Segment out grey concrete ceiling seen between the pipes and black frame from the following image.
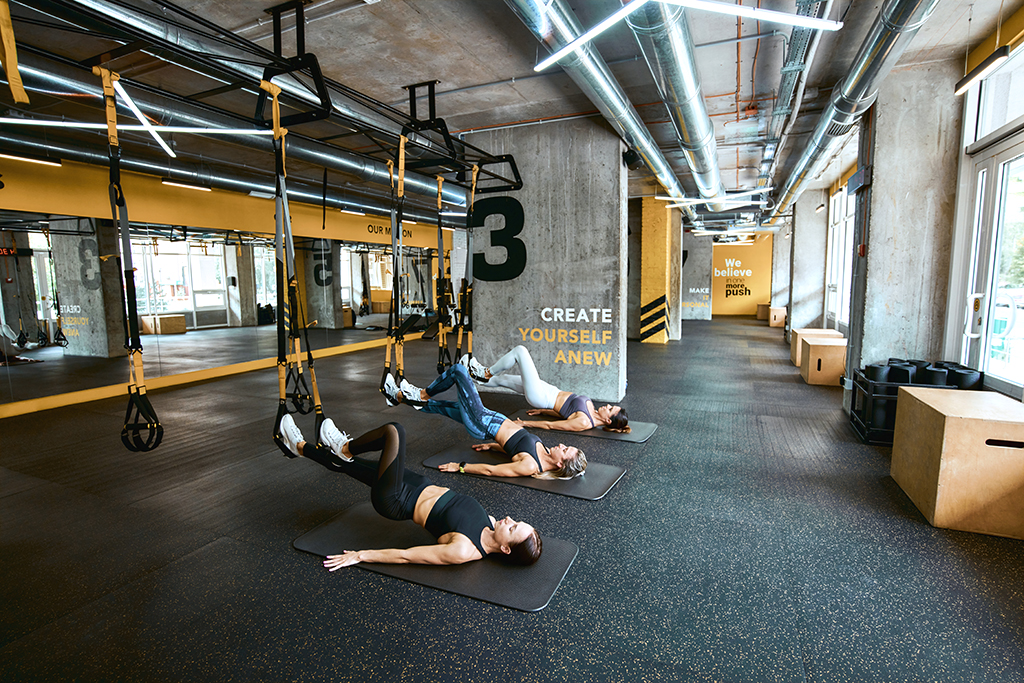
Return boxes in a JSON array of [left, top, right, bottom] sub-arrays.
[[0, 0, 1007, 229]]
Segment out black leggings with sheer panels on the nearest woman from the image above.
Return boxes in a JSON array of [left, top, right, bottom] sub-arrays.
[[302, 422, 431, 520]]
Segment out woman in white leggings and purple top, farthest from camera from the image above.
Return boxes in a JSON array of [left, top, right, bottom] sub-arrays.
[[459, 345, 630, 433]]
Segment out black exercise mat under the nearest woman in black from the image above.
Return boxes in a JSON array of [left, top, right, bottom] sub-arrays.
[[292, 502, 580, 612]]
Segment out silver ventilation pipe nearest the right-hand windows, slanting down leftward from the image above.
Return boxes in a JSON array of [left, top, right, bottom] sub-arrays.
[[768, 0, 938, 224]]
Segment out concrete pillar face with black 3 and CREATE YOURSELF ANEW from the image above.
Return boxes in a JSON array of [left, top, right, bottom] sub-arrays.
[[467, 119, 627, 400]]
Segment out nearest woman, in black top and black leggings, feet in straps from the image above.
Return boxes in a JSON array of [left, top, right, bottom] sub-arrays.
[[281, 415, 541, 571]]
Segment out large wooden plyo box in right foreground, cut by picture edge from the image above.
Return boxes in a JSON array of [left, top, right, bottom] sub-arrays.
[[890, 387, 1024, 540]]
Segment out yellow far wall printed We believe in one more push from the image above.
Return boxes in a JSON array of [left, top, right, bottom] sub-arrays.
[[711, 232, 772, 315]]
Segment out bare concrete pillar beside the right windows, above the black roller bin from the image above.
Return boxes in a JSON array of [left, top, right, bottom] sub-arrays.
[[850, 60, 963, 368]]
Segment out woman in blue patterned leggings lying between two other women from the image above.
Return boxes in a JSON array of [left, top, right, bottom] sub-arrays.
[[384, 366, 587, 479]]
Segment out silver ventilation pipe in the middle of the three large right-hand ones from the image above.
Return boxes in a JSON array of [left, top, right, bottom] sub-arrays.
[[626, 2, 726, 212]]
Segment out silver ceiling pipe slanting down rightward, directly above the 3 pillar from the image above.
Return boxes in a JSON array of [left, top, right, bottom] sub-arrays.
[[505, 0, 696, 220]]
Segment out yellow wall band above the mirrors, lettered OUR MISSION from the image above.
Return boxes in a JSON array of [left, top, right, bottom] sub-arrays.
[[0, 159, 451, 249]]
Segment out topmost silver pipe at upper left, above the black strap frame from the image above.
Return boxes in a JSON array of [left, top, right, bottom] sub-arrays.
[[51, 0, 464, 181]]
